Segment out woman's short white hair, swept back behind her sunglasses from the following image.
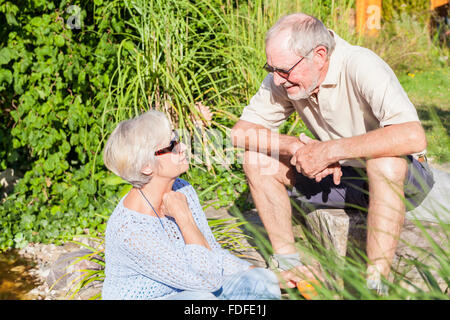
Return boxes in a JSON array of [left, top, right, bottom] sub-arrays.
[[103, 110, 171, 188]]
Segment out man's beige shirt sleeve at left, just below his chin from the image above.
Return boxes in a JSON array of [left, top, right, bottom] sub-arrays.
[[240, 74, 295, 131]]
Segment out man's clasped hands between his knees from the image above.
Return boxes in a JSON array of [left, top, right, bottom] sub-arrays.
[[291, 133, 342, 185]]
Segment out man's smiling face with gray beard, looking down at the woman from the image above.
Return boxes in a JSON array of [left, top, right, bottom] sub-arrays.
[[266, 32, 320, 100]]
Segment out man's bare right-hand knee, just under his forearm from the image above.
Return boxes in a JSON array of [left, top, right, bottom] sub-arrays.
[[366, 157, 408, 185]]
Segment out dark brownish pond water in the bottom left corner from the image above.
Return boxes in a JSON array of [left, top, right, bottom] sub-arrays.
[[0, 250, 39, 300]]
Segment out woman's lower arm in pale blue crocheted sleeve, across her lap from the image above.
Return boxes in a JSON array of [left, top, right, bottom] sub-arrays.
[[117, 221, 224, 291]]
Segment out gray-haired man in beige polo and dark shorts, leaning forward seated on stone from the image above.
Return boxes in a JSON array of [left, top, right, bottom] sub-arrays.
[[231, 13, 434, 293]]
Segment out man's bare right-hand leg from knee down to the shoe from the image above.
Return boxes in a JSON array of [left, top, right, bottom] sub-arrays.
[[367, 157, 408, 278]]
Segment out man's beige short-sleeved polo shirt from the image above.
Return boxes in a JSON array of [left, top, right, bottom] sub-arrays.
[[240, 31, 419, 167]]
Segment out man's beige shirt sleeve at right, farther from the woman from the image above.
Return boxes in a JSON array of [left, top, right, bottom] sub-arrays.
[[347, 48, 419, 127]]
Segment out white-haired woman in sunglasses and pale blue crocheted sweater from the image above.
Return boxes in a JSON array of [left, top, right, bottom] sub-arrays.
[[102, 111, 280, 300]]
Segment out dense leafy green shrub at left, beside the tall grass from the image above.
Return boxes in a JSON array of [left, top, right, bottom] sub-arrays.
[[0, 1, 126, 249]]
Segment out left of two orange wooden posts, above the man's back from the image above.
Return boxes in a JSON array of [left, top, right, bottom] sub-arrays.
[[356, 0, 382, 36]]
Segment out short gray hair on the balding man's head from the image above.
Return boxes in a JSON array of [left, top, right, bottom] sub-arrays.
[[266, 13, 336, 57]]
